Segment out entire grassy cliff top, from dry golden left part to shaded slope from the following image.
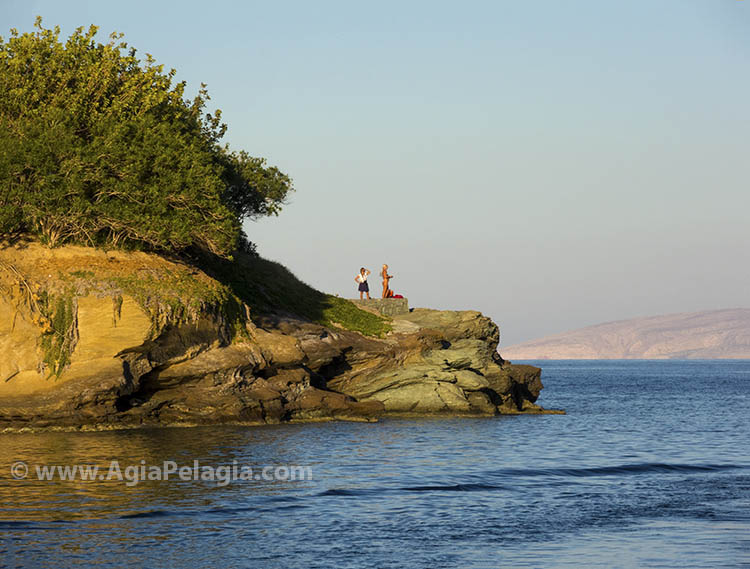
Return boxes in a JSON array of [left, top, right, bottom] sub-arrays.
[[4, 242, 391, 338]]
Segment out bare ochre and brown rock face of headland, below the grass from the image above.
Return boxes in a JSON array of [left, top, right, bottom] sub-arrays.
[[0, 244, 556, 429]]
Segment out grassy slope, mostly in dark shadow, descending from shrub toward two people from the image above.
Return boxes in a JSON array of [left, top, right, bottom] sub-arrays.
[[202, 254, 391, 337]]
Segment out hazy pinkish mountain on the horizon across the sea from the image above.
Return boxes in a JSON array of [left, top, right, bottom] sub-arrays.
[[500, 308, 750, 360]]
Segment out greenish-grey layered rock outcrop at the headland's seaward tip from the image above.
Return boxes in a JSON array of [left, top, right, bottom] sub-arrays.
[[327, 309, 542, 415]]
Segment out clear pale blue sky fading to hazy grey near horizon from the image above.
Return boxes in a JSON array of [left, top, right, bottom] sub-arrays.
[[0, 0, 750, 344]]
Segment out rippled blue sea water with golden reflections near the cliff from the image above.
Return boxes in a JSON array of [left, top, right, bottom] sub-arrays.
[[0, 361, 750, 568]]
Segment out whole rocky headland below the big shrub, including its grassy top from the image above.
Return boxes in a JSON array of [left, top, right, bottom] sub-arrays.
[[0, 242, 560, 430]]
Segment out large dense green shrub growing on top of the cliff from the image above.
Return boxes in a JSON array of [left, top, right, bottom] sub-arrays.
[[0, 18, 292, 255]]
